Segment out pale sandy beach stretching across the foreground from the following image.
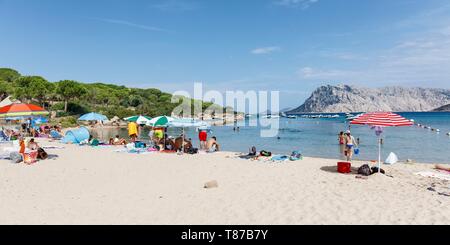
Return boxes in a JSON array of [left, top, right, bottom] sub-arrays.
[[0, 140, 450, 225]]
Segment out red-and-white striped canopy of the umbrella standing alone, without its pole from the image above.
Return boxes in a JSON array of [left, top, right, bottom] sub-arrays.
[[351, 112, 414, 127]]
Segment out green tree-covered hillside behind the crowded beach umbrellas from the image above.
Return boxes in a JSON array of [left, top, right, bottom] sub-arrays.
[[0, 68, 225, 118]]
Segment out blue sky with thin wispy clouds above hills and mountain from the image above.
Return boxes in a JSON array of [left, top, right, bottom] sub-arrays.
[[0, 0, 450, 107]]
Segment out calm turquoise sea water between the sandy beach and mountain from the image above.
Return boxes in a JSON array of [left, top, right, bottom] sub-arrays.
[[96, 112, 450, 163]]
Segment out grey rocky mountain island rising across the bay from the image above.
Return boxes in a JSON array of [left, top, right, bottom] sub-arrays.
[[288, 85, 450, 114]]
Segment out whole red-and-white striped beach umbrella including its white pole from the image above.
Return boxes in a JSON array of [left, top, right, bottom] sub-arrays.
[[350, 112, 414, 172]]
